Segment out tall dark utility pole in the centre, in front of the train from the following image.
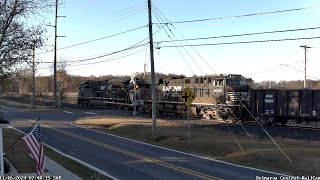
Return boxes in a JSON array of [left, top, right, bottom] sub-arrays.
[[148, 0, 157, 136]]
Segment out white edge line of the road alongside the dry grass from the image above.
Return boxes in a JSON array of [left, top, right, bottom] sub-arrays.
[[69, 123, 289, 177]]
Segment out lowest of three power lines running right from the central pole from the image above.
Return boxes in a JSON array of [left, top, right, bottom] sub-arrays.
[[161, 36, 320, 48]]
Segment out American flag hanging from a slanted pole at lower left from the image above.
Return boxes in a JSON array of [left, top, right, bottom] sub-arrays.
[[22, 124, 45, 176]]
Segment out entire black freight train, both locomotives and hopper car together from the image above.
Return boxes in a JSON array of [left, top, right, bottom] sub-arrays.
[[78, 74, 320, 126]]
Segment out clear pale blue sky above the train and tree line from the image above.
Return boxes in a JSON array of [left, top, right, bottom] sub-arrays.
[[32, 0, 320, 81]]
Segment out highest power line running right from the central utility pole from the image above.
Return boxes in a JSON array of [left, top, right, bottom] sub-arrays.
[[156, 5, 320, 24]]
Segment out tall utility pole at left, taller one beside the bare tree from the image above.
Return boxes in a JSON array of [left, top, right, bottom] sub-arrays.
[[53, 0, 58, 106]]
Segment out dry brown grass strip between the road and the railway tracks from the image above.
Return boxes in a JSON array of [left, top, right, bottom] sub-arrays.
[[76, 116, 320, 176]]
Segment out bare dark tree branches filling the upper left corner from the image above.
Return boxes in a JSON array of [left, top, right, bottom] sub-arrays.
[[0, 0, 50, 77]]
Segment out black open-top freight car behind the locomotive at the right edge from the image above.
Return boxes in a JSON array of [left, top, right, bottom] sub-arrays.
[[250, 89, 320, 125]]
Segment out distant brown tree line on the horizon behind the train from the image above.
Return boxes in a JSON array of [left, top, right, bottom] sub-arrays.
[[0, 66, 320, 96]]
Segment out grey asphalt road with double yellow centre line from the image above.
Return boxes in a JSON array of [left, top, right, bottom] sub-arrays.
[[2, 109, 288, 180]]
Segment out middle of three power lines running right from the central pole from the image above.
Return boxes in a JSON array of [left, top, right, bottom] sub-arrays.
[[156, 26, 320, 43]]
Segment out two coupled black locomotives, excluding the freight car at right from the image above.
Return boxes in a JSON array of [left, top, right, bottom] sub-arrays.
[[78, 74, 251, 119]]
